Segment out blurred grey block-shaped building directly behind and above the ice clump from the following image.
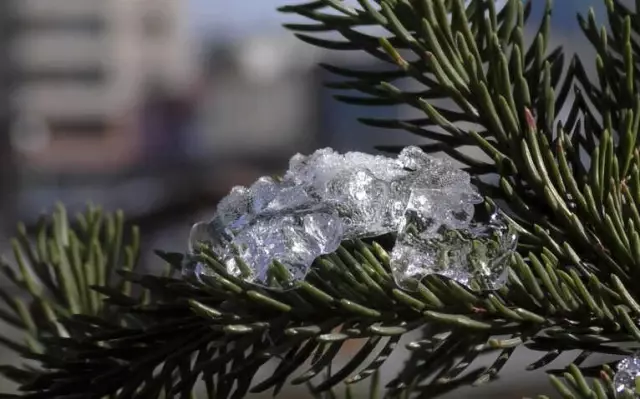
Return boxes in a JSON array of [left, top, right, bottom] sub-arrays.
[[192, 35, 316, 164]]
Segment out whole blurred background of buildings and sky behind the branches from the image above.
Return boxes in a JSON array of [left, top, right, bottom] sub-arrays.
[[0, 0, 620, 398]]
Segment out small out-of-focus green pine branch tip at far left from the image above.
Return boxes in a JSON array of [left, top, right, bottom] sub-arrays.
[[0, 206, 146, 383]]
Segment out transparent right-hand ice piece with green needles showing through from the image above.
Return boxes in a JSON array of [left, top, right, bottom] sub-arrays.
[[391, 199, 517, 290]]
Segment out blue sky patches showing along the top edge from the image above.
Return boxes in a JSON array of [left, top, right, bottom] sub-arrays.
[[194, 0, 604, 36]]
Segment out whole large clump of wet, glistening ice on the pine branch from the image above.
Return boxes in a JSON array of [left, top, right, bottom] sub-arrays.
[[190, 147, 515, 288]]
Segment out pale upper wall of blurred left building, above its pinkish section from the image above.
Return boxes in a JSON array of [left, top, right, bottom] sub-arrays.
[[11, 0, 194, 125]]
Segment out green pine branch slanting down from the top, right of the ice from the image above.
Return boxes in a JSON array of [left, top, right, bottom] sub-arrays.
[[282, 0, 599, 266]]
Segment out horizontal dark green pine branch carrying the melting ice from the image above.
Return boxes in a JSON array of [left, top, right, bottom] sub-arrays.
[[5, 219, 640, 398]]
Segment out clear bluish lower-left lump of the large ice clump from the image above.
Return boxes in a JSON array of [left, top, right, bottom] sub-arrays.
[[190, 194, 344, 286]]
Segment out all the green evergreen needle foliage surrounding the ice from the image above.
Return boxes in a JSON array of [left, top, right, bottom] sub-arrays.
[[0, 0, 640, 399]]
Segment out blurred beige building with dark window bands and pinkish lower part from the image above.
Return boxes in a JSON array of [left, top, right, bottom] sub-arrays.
[[8, 0, 195, 173]]
